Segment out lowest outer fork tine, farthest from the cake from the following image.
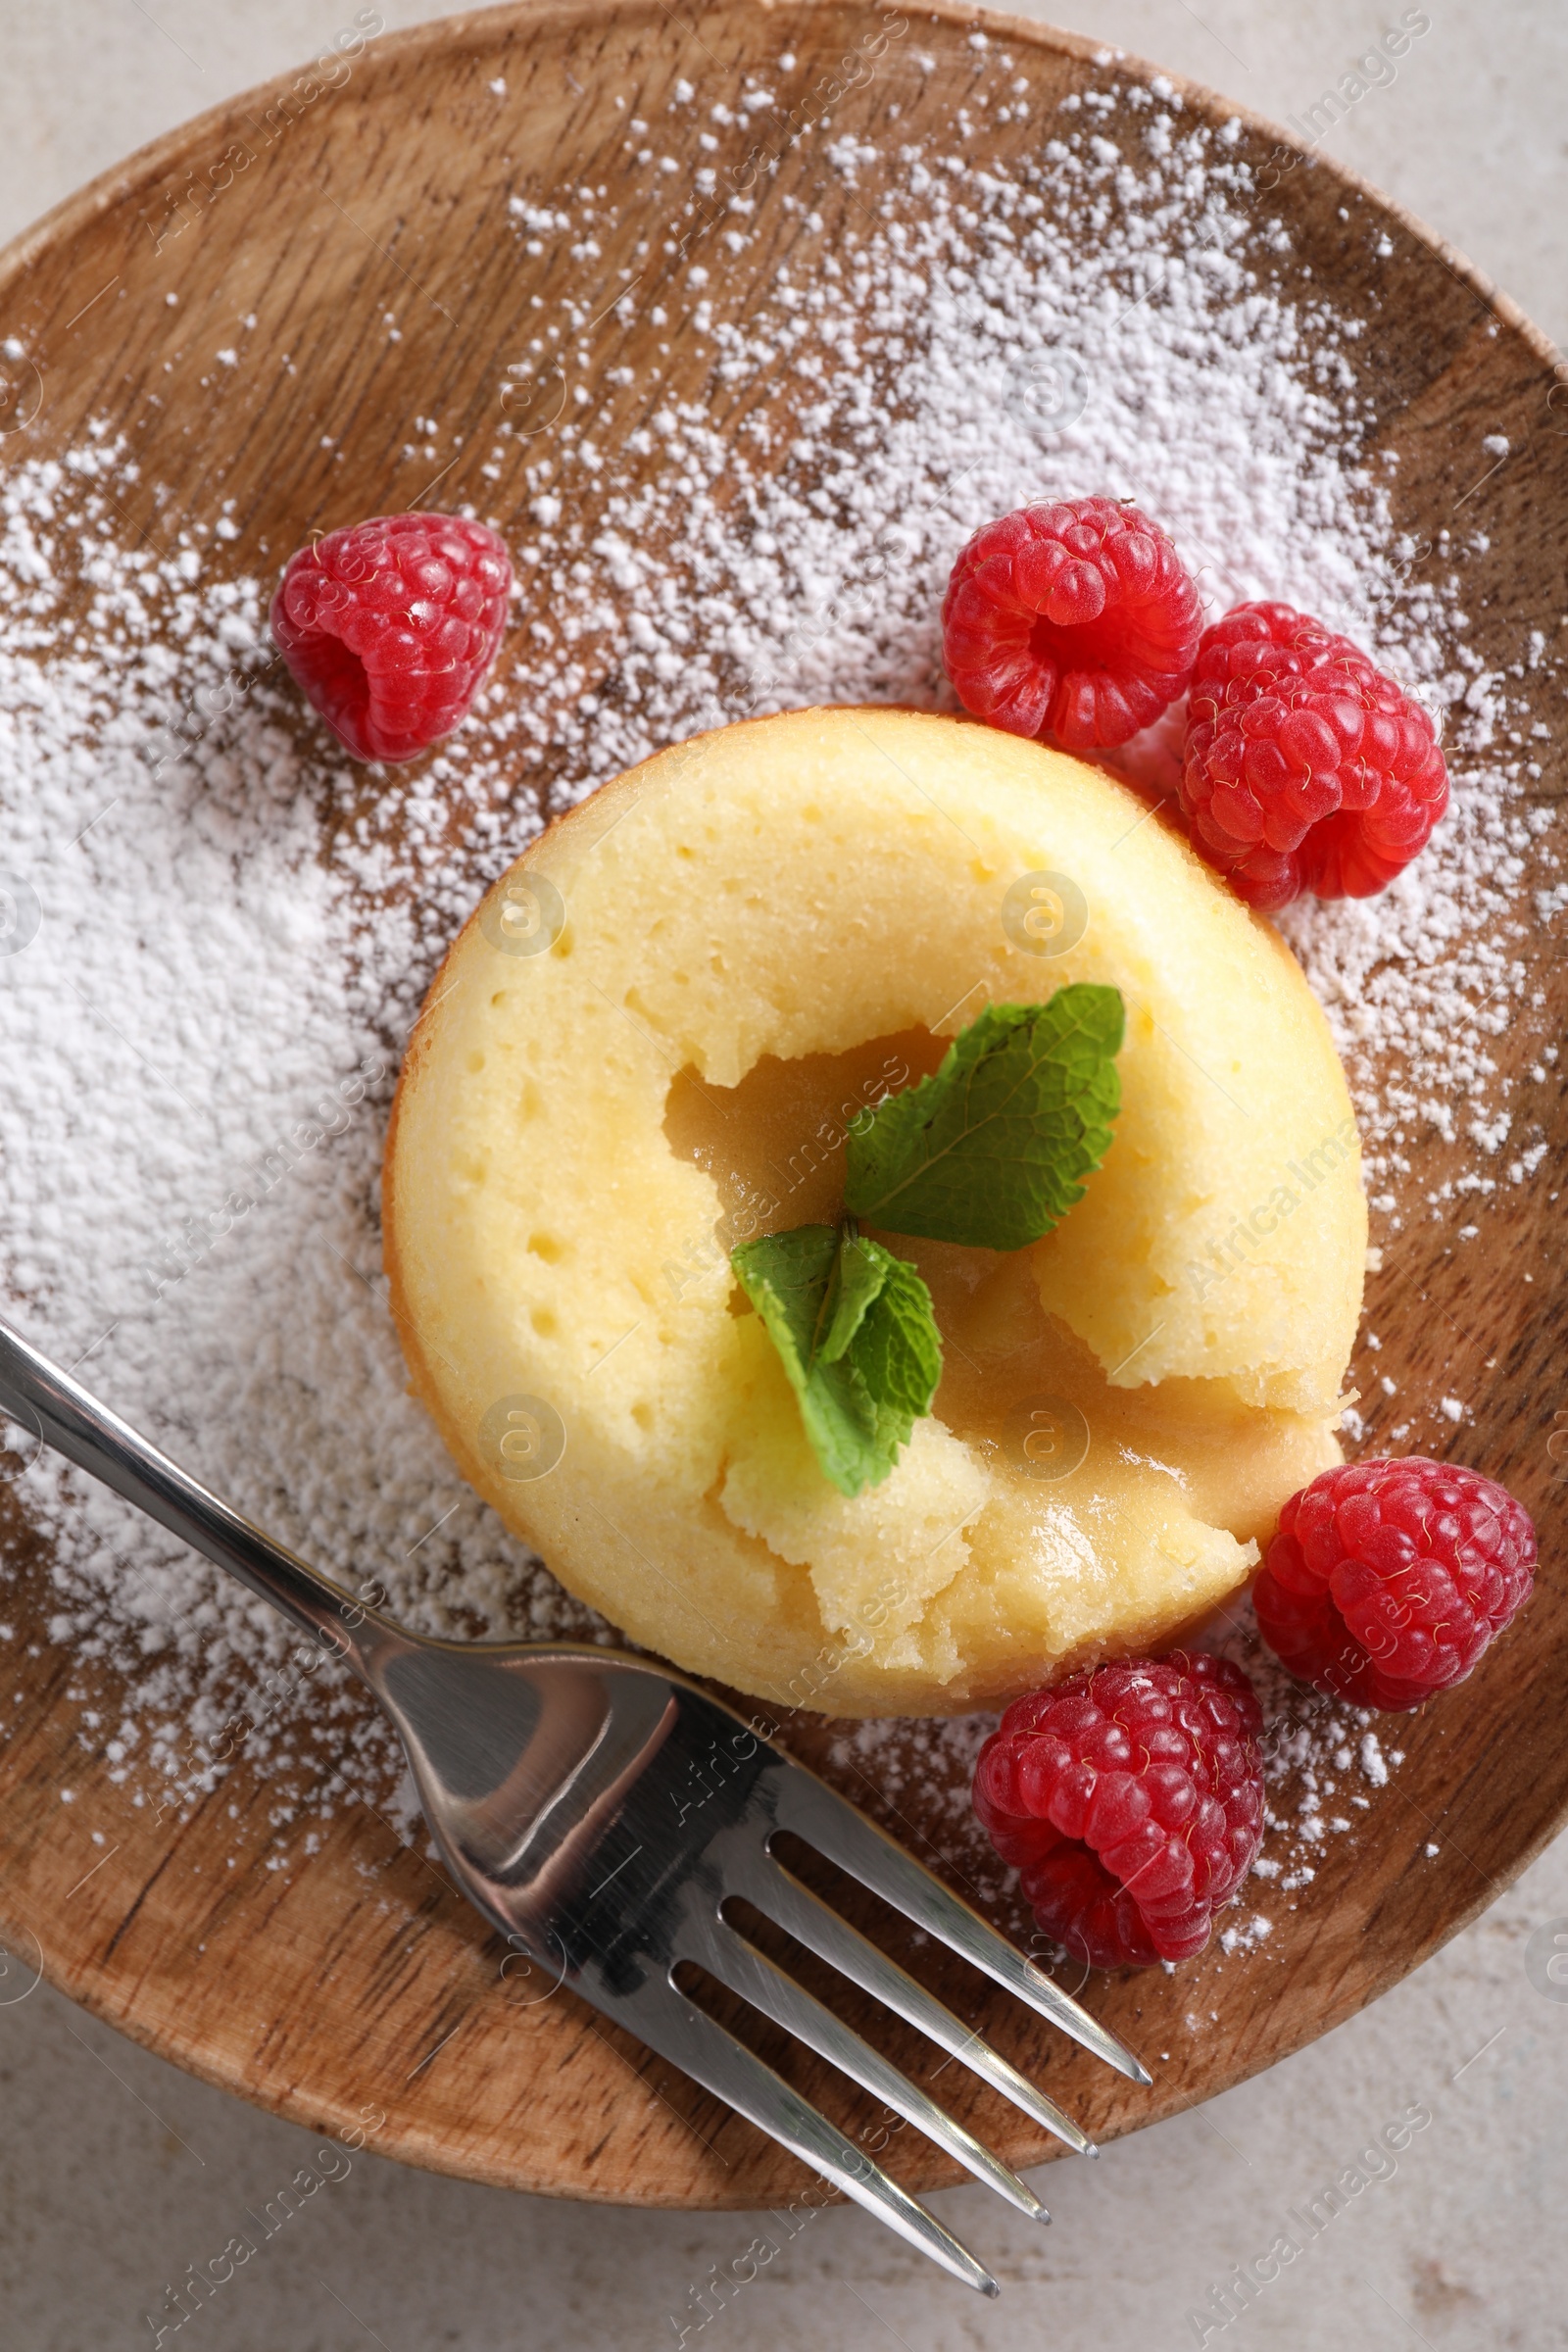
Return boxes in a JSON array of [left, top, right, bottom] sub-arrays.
[[600, 1981, 999, 2295]]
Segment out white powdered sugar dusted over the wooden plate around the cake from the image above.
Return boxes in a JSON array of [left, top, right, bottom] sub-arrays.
[[0, 57, 1549, 1882]]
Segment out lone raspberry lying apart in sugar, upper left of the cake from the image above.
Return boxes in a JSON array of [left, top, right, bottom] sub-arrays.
[[272, 515, 513, 760]]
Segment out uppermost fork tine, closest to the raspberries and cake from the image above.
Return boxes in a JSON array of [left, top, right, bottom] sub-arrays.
[[773, 1762, 1154, 2082]]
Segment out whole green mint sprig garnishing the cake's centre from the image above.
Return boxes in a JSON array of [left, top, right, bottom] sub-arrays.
[[731, 981, 1126, 1495]]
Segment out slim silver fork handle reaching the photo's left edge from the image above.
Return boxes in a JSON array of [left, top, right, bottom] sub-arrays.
[[0, 1322, 393, 1675]]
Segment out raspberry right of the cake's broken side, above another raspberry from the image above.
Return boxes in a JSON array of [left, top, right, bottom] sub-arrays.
[[1253, 1453, 1535, 1712]]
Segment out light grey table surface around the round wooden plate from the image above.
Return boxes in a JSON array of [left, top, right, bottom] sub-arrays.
[[0, 0, 1568, 2352]]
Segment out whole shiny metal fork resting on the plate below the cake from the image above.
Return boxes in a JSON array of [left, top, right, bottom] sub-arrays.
[[0, 1322, 1150, 2295]]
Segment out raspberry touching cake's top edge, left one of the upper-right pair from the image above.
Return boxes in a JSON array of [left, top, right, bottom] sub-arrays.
[[943, 499, 1201, 751]]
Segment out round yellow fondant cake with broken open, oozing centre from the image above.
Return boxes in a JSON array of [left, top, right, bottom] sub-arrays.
[[385, 710, 1366, 1715]]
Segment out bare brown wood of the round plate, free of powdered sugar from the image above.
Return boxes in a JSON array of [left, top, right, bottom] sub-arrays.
[[0, 0, 1568, 2206]]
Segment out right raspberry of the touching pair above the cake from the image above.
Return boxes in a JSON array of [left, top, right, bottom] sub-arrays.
[[1180, 605, 1448, 907]]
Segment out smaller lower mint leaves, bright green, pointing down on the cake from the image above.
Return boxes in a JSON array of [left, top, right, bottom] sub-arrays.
[[729, 1225, 943, 1494]]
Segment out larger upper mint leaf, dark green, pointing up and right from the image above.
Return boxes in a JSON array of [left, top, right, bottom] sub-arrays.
[[844, 981, 1124, 1249]]
